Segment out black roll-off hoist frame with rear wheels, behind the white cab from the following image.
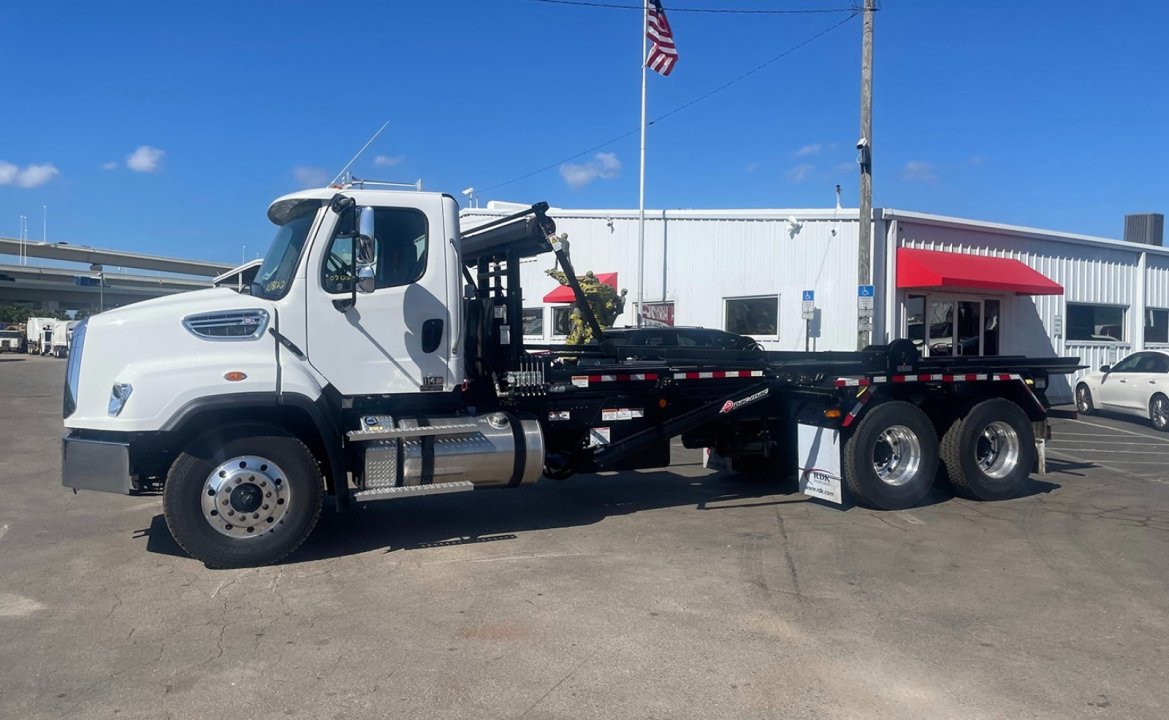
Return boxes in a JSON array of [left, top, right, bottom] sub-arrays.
[[451, 203, 1080, 510]]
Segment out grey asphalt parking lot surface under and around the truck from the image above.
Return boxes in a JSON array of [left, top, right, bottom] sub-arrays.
[[0, 358, 1169, 719]]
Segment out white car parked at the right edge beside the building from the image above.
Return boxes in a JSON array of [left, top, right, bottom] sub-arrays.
[[1075, 349, 1169, 431]]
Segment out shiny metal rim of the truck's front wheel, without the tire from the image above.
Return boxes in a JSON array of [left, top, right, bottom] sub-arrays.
[[202, 455, 292, 538]]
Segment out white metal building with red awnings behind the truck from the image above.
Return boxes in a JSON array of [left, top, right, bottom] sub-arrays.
[[463, 203, 1169, 401]]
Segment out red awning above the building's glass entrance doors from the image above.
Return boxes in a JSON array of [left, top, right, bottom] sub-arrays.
[[897, 248, 1064, 295]]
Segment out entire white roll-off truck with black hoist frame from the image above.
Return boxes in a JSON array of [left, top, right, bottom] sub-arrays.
[[62, 182, 1079, 567]]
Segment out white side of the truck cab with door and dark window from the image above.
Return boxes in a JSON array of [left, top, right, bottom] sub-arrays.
[[305, 192, 457, 395]]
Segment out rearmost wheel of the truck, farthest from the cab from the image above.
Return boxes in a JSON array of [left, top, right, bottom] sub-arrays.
[[941, 397, 1036, 500]]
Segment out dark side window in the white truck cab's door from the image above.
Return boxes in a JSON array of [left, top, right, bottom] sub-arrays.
[[320, 208, 429, 292]]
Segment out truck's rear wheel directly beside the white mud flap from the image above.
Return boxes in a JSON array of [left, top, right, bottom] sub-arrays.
[[844, 401, 938, 510]]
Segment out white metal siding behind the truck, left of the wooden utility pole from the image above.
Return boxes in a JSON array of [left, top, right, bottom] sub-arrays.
[[463, 210, 858, 349]]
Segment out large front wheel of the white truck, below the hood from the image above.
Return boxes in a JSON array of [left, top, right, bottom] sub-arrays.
[[162, 424, 324, 568]]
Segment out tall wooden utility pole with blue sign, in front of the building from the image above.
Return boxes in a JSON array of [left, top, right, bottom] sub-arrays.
[[857, 0, 874, 349]]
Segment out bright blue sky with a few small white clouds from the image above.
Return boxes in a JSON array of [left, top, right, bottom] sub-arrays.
[[0, 0, 1169, 262]]
